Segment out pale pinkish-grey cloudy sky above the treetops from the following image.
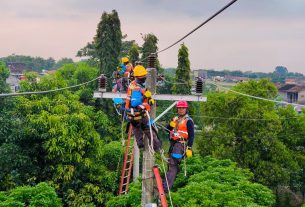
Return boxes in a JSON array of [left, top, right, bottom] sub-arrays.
[[0, 0, 305, 74]]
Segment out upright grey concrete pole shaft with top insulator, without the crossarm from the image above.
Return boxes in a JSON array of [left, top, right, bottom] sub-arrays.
[[141, 54, 157, 206]]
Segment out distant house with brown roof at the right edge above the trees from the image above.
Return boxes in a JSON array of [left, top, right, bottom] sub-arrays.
[[278, 84, 305, 104]]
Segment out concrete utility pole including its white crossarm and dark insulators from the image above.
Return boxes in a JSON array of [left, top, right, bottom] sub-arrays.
[[94, 59, 207, 207]]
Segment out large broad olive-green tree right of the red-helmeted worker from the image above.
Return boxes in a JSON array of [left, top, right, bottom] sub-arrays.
[[197, 80, 305, 205]]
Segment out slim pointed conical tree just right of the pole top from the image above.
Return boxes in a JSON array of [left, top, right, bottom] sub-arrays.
[[173, 44, 192, 94]]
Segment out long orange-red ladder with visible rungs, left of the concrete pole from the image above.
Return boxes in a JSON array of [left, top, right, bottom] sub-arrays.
[[119, 124, 134, 195]]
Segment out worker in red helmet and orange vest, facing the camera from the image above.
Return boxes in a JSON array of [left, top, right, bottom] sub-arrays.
[[163, 101, 195, 192]]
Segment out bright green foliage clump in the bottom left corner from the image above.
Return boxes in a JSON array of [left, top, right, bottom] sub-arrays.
[[0, 183, 62, 207]]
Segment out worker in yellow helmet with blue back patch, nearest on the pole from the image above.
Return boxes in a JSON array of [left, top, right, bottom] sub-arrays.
[[125, 65, 161, 151]]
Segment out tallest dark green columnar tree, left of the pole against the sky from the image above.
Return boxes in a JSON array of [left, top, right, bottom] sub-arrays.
[[94, 10, 122, 79]]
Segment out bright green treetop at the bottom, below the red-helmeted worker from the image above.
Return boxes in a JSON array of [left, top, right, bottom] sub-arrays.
[[172, 157, 275, 207]]
